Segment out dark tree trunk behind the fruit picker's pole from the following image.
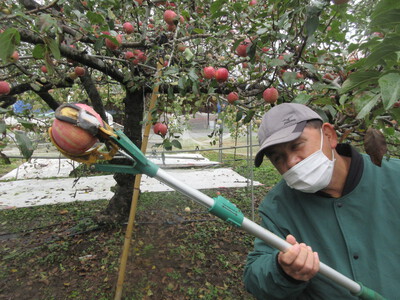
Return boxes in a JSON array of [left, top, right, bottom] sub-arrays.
[[101, 91, 144, 222]]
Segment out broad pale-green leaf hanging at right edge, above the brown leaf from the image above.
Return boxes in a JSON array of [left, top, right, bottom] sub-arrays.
[[378, 73, 400, 110]]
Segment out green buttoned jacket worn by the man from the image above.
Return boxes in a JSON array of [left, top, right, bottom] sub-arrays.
[[244, 155, 400, 300]]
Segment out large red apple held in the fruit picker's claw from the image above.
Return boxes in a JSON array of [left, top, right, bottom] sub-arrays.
[[51, 103, 103, 154]]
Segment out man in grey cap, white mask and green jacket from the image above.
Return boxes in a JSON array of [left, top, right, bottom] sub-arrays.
[[244, 103, 400, 300]]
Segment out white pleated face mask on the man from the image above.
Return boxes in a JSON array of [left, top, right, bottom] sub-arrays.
[[282, 129, 335, 193]]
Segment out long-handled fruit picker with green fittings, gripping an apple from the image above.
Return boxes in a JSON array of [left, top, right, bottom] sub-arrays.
[[49, 104, 385, 300]]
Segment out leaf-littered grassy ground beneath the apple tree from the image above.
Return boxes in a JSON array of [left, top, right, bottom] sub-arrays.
[[0, 113, 279, 299]]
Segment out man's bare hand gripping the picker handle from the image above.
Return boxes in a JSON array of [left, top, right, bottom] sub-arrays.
[[278, 234, 319, 281]]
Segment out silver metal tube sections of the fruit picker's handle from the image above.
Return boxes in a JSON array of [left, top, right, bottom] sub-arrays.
[[154, 169, 361, 294]]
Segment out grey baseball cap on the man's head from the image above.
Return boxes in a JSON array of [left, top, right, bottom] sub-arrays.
[[254, 103, 322, 167]]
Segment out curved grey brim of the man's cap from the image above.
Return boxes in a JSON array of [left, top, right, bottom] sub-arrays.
[[254, 121, 307, 167]]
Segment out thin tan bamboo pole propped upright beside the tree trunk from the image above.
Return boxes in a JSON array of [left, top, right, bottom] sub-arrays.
[[114, 60, 163, 300]]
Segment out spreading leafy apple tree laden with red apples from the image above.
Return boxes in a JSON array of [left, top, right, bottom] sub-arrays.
[[0, 0, 400, 218]]
